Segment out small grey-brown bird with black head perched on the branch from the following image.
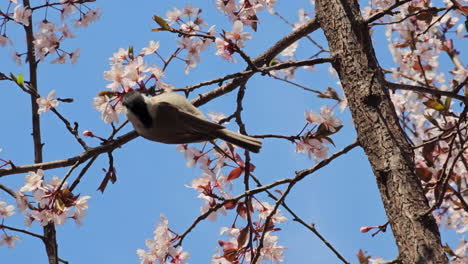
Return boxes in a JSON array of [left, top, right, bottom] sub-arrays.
[[122, 90, 262, 153]]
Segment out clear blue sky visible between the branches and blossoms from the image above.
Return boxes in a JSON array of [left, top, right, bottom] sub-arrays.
[[0, 0, 457, 264]]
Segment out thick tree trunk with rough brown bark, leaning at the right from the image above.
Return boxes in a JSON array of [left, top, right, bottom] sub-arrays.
[[316, 0, 448, 264]]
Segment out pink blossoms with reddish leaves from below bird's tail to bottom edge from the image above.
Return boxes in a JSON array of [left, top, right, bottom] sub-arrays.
[[177, 139, 286, 264]]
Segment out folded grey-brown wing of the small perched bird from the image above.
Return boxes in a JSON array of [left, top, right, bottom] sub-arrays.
[[155, 102, 224, 135]]
